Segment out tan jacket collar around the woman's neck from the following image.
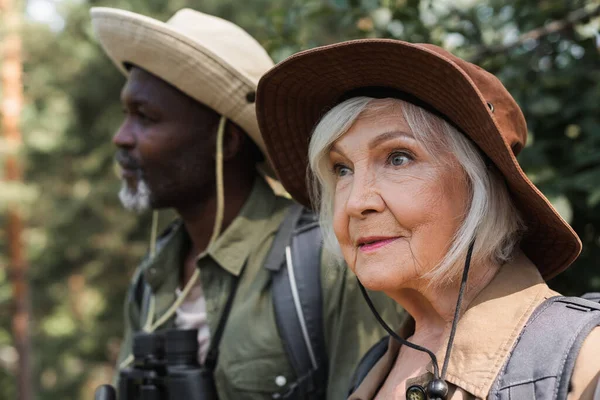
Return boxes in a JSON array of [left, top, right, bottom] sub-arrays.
[[351, 253, 557, 399]]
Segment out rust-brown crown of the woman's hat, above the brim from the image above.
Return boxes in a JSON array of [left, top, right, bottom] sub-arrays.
[[420, 44, 527, 156]]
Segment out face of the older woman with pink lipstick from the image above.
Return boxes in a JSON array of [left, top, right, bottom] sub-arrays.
[[329, 100, 468, 293]]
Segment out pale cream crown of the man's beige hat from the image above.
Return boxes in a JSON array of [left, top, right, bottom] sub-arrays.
[[166, 8, 273, 85]]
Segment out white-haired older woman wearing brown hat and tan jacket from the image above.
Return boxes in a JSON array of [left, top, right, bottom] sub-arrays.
[[257, 39, 600, 400]]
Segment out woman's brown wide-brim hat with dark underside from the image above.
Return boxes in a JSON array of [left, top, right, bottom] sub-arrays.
[[256, 39, 581, 279]]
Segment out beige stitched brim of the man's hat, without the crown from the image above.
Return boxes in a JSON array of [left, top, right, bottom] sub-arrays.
[[91, 7, 266, 162]]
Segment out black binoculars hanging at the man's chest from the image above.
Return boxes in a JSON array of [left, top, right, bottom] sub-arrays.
[[95, 329, 218, 400]]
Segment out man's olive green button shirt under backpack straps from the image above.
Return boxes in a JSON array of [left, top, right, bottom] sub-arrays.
[[119, 178, 402, 400]]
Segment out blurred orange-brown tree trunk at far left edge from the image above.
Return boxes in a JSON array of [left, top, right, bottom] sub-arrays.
[[0, 0, 32, 400]]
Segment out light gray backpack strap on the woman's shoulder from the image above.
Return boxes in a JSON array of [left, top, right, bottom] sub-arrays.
[[488, 296, 600, 400]]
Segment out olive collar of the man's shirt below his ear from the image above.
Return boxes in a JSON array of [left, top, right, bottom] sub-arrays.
[[197, 177, 280, 276]]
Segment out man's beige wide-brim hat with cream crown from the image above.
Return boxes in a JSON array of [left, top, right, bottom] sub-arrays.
[[91, 7, 273, 155]]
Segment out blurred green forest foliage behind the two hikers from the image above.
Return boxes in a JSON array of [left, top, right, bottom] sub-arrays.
[[0, 0, 600, 399]]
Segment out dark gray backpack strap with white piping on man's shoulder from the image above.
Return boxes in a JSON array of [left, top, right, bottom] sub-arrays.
[[265, 205, 327, 400]]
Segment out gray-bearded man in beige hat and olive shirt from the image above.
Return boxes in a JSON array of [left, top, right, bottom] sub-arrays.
[[91, 8, 399, 399]]
